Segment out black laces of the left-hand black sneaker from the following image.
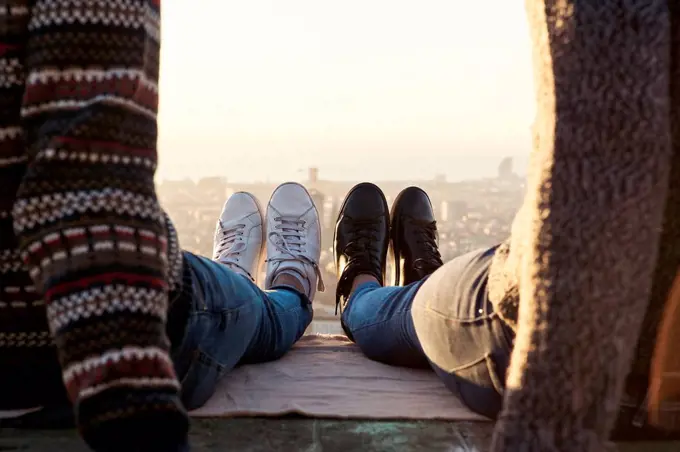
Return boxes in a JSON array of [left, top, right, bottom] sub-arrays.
[[335, 218, 380, 315]]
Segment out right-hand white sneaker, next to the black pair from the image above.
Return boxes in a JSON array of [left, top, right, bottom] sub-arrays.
[[265, 182, 325, 301]]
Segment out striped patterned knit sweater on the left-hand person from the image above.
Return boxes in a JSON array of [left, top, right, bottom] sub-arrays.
[[0, 0, 188, 451]]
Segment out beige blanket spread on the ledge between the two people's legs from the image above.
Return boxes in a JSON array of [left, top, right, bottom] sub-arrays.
[[0, 335, 485, 420]]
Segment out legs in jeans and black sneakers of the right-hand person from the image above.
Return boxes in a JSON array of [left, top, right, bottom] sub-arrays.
[[335, 184, 514, 418]]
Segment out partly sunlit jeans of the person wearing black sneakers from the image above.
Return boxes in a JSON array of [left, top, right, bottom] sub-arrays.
[[342, 247, 514, 418]]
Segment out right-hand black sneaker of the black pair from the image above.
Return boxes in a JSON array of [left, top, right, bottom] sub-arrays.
[[390, 187, 443, 286]]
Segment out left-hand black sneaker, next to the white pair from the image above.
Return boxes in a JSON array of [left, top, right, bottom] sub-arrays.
[[333, 183, 390, 339]]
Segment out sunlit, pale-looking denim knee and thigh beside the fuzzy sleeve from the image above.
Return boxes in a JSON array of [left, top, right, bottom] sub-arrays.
[[412, 248, 514, 418]]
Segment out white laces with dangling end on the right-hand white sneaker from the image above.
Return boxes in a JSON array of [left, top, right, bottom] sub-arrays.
[[266, 216, 326, 292]]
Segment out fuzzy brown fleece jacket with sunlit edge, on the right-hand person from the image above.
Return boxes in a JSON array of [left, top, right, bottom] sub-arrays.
[[489, 0, 680, 452]]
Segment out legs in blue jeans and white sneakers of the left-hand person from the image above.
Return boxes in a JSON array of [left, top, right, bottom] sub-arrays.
[[167, 183, 323, 410]]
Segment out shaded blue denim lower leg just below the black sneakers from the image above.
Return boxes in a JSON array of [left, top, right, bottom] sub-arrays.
[[342, 281, 428, 367]]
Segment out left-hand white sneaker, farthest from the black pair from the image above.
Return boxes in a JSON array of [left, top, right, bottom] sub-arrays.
[[213, 192, 264, 282]]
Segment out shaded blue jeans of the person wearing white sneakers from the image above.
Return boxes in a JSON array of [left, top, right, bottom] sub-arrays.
[[170, 252, 313, 410]]
